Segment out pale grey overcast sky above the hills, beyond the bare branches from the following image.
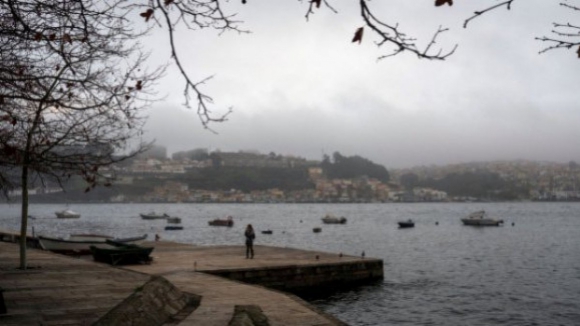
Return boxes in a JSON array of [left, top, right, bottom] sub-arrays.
[[146, 0, 580, 169]]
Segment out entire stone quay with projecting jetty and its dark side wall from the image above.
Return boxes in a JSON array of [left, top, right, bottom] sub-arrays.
[[0, 233, 383, 326]]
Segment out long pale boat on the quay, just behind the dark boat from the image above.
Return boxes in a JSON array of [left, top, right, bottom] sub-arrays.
[[38, 234, 147, 255]]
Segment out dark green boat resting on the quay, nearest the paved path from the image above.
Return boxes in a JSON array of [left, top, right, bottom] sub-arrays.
[[90, 240, 154, 266]]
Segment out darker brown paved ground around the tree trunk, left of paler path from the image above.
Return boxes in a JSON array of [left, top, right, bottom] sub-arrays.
[[0, 242, 150, 326]]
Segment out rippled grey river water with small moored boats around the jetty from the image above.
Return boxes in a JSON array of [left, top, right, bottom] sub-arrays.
[[0, 203, 580, 326]]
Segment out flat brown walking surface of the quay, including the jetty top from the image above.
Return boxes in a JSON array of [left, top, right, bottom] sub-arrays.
[[0, 242, 348, 326]]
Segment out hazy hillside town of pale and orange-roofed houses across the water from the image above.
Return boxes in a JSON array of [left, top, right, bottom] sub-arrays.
[[11, 146, 580, 203]]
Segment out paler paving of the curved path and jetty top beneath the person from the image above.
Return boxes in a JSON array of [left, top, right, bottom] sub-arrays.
[[124, 242, 360, 326]]
